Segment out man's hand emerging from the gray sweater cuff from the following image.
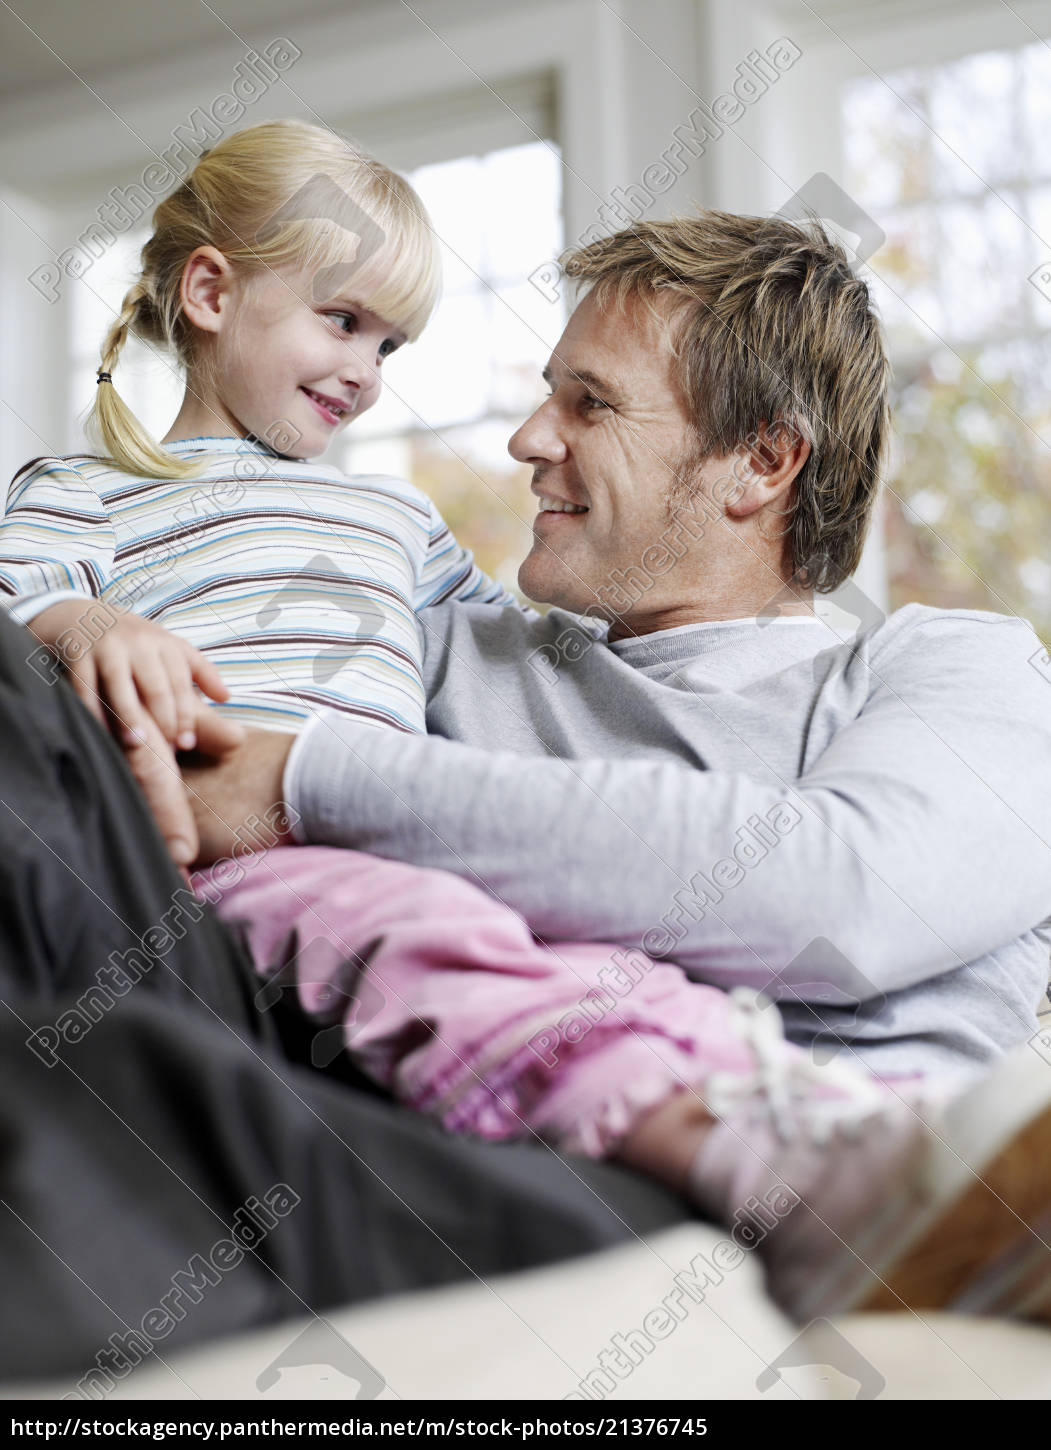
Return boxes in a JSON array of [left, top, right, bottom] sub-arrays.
[[180, 729, 296, 866]]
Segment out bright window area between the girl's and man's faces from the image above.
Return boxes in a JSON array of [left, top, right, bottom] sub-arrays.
[[341, 142, 564, 587]]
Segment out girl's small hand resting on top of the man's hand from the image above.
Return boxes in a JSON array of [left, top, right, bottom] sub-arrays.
[[29, 599, 229, 750]]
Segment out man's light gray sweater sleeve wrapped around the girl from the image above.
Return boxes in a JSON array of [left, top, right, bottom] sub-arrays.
[[286, 616, 1051, 1001]]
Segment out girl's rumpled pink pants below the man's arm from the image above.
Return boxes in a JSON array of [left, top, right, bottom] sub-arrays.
[[194, 845, 752, 1157]]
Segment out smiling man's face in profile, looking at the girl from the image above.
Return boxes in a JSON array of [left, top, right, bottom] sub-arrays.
[[507, 297, 725, 621]]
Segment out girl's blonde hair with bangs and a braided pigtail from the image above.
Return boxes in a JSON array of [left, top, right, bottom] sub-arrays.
[[88, 120, 441, 479]]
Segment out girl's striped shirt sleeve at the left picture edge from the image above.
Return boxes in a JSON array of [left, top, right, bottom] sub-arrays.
[[0, 458, 115, 624]]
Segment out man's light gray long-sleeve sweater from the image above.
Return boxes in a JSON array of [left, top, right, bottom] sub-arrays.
[[286, 605, 1051, 1074]]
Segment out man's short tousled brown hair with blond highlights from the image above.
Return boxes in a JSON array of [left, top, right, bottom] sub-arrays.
[[562, 212, 890, 593]]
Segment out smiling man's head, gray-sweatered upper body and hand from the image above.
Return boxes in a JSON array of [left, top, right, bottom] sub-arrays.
[[168, 213, 1051, 1077]]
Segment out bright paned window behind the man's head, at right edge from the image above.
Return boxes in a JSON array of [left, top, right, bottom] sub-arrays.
[[844, 42, 1051, 638]]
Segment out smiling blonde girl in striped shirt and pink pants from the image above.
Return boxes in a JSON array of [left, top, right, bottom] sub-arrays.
[[0, 122, 1032, 1315]]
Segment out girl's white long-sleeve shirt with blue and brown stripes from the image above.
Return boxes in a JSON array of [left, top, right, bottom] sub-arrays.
[[0, 438, 510, 731]]
